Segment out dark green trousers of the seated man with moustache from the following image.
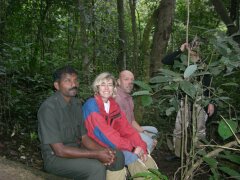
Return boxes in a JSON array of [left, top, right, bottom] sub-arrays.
[[45, 151, 124, 180]]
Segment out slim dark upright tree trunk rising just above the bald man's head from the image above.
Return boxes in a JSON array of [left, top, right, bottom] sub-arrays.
[[117, 0, 126, 71]]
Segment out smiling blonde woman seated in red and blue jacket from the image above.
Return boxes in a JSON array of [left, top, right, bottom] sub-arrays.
[[83, 72, 157, 175]]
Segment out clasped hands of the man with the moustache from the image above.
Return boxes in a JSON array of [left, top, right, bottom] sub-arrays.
[[98, 148, 116, 165]]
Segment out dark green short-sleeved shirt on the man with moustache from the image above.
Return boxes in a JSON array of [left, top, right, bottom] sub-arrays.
[[38, 92, 87, 165]]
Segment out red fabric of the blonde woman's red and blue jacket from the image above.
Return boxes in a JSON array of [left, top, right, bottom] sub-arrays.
[[83, 96, 147, 153]]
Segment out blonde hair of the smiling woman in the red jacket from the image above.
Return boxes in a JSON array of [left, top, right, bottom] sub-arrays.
[[92, 72, 117, 96]]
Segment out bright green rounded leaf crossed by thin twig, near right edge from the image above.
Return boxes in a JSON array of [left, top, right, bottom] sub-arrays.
[[218, 120, 237, 140]]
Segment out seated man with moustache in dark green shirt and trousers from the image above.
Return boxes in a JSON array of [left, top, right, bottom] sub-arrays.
[[38, 66, 126, 180]]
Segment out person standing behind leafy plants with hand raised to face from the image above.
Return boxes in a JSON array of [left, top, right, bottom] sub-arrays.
[[162, 39, 215, 157]]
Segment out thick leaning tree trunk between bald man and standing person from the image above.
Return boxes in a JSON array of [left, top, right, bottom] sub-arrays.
[[149, 0, 176, 77]]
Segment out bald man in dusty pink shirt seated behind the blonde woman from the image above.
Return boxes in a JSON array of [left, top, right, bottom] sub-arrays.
[[115, 70, 158, 153]]
